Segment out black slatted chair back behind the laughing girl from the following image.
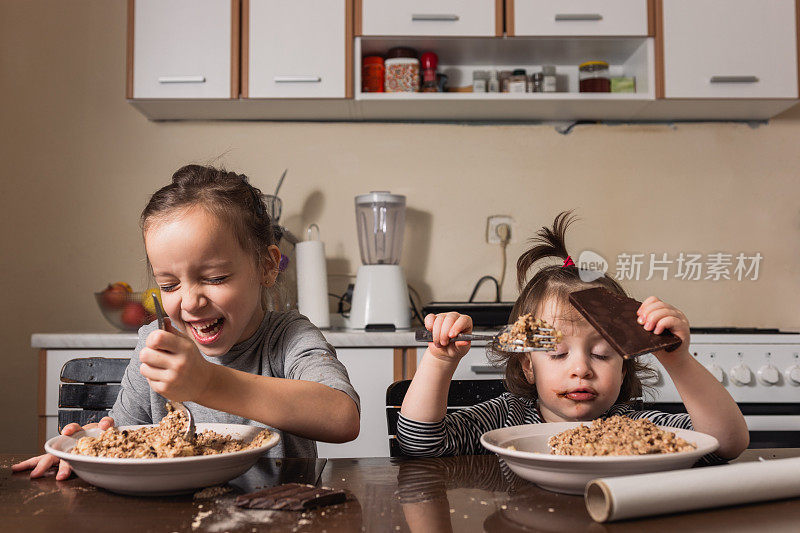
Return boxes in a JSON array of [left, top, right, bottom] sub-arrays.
[[58, 357, 129, 433]]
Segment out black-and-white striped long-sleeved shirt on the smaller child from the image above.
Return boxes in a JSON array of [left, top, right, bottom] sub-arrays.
[[397, 392, 724, 464]]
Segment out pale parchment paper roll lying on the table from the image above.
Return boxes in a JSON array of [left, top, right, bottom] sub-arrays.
[[584, 457, 800, 522]]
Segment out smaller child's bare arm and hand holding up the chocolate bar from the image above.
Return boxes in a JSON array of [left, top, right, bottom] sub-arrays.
[[638, 296, 750, 459]]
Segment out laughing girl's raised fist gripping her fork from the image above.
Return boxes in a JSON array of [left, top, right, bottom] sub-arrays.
[[139, 318, 214, 402]]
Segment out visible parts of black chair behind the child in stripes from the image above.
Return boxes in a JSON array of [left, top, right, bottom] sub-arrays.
[[386, 379, 506, 457]]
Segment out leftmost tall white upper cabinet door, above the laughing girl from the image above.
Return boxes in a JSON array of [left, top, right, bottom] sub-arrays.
[[129, 0, 234, 98]]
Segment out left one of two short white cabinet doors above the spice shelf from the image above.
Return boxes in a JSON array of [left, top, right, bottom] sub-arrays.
[[362, 0, 496, 37]]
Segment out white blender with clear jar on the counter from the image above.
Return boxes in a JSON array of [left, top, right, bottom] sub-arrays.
[[347, 191, 411, 331]]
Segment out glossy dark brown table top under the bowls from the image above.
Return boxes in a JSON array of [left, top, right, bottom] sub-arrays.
[[0, 448, 800, 533]]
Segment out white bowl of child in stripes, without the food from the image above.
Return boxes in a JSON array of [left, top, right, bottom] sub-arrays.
[[481, 422, 719, 494]]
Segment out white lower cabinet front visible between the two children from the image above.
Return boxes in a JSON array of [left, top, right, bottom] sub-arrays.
[[317, 348, 394, 457]]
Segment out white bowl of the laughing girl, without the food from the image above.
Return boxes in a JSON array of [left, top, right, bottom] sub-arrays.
[[44, 423, 280, 496]]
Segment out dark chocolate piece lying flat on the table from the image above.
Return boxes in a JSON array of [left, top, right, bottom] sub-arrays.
[[236, 483, 347, 511]]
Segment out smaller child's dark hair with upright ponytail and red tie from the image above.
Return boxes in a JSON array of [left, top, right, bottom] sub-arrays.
[[489, 211, 655, 403]]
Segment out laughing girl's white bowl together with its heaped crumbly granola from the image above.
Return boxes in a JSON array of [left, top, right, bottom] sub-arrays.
[[44, 412, 280, 496]]
